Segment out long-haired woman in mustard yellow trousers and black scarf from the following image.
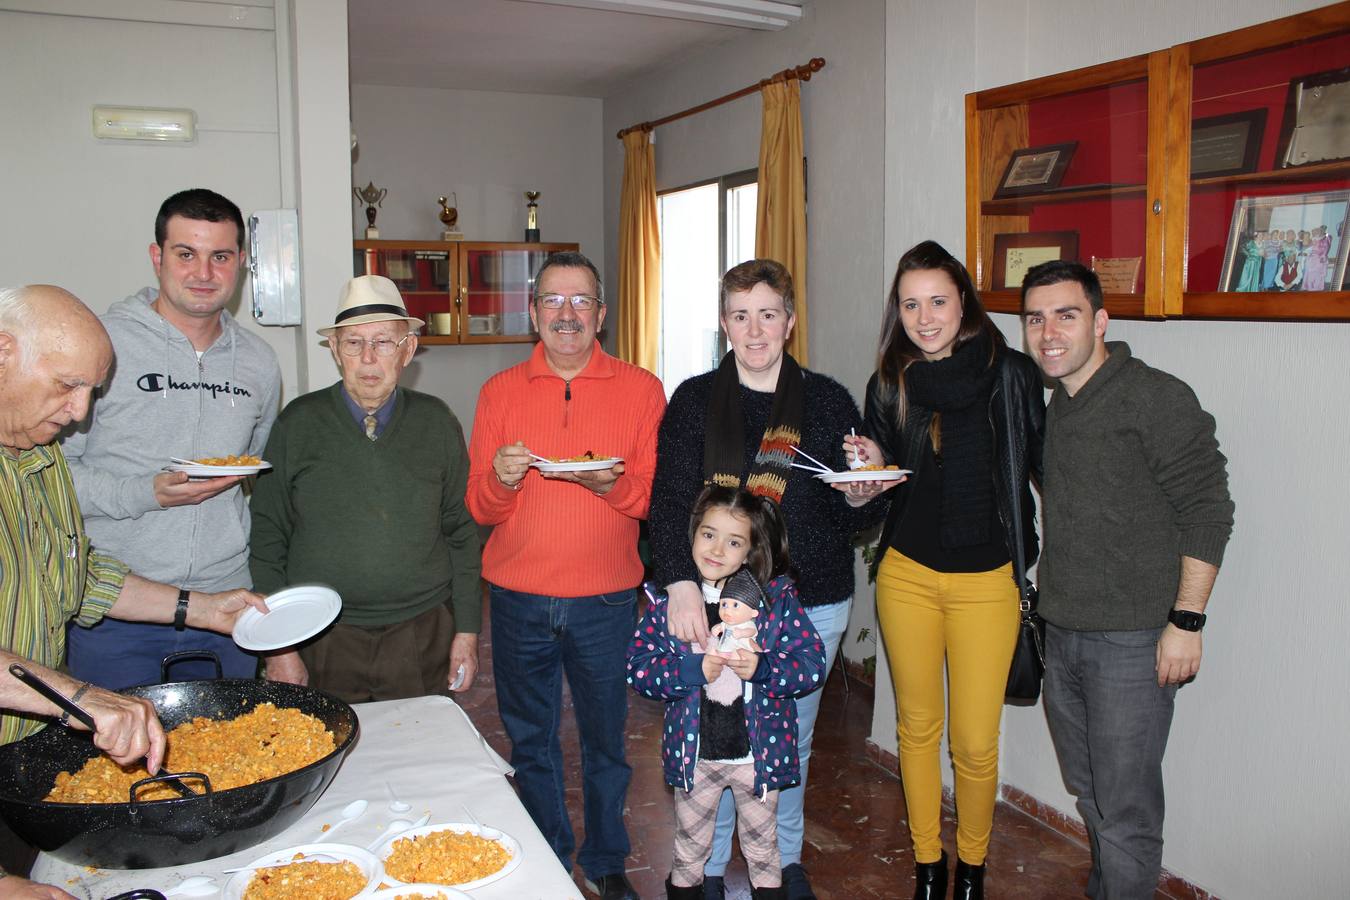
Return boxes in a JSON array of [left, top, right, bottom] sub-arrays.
[[845, 240, 1045, 900]]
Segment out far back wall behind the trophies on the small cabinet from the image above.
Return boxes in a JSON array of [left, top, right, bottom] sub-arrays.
[[348, 84, 604, 430]]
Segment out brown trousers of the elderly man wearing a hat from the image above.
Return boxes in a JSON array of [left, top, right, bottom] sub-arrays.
[[300, 604, 455, 703]]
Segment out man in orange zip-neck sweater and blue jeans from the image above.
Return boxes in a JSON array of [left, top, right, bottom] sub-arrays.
[[467, 252, 666, 900]]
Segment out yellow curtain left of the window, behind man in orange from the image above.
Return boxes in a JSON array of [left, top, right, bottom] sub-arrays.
[[617, 131, 662, 374]]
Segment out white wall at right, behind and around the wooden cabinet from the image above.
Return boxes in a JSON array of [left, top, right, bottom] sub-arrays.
[[872, 0, 1350, 900]]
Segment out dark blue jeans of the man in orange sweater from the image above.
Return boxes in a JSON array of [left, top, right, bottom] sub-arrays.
[[490, 584, 637, 880]]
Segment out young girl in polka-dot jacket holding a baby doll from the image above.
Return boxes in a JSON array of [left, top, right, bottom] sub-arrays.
[[628, 484, 825, 900]]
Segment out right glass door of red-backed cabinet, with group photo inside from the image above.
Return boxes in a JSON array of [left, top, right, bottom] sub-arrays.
[[1168, 20, 1350, 318]]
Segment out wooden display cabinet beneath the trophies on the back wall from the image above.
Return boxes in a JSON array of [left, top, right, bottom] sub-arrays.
[[352, 240, 578, 344]]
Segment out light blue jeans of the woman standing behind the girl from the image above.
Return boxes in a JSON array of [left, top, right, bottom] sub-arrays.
[[703, 596, 853, 877]]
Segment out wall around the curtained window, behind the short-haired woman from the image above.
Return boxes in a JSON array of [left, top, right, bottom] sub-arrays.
[[603, 0, 886, 669]]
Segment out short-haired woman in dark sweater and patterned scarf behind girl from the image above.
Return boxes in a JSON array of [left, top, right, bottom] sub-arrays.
[[648, 259, 886, 900]]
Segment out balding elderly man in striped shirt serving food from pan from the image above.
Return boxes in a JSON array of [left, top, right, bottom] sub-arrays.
[[0, 285, 267, 897]]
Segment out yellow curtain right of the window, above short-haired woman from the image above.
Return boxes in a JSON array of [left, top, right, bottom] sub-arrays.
[[755, 78, 807, 366]]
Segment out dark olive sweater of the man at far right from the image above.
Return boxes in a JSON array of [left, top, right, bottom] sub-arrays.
[[1038, 341, 1233, 631]]
